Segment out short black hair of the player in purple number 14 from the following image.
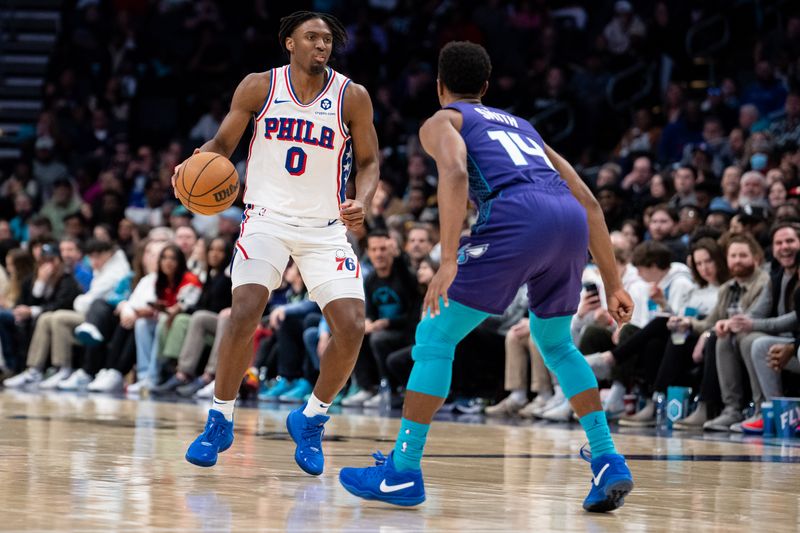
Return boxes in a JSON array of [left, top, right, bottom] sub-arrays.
[[439, 41, 492, 95]]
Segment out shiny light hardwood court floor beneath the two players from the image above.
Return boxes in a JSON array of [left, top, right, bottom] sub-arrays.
[[0, 391, 800, 533]]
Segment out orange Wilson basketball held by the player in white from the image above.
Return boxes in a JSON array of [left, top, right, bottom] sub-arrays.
[[175, 152, 239, 215]]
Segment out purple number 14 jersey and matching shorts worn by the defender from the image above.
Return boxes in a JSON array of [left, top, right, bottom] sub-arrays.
[[447, 102, 589, 318]]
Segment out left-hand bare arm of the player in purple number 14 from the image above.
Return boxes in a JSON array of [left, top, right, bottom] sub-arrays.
[[419, 109, 469, 316]]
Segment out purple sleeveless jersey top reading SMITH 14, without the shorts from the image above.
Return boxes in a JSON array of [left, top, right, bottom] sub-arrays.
[[446, 102, 569, 231]]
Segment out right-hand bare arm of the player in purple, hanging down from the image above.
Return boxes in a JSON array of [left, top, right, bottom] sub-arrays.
[[544, 145, 633, 324]]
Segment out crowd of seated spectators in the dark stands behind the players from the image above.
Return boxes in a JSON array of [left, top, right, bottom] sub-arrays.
[[0, 0, 800, 430]]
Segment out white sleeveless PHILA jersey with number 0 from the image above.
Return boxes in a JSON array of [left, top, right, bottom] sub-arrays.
[[244, 65, 353, 220]]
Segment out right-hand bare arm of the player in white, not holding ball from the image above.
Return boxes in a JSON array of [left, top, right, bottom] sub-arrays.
[[339, 82, 380, 229]]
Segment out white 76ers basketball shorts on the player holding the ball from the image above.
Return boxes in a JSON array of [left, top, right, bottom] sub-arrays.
[[231, 206, 364, 309]]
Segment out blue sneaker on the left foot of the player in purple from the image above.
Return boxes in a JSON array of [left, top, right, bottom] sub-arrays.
[[339, 452, 425, 507]]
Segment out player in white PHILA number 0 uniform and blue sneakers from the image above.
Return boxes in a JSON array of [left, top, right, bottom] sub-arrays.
[[181, 11, 378, 475]]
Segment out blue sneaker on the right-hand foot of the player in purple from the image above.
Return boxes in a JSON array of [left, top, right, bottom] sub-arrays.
[[581, 449, 633, 513]]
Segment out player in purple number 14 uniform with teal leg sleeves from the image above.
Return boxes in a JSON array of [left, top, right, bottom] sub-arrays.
[[339, 42, 633, 512]]
